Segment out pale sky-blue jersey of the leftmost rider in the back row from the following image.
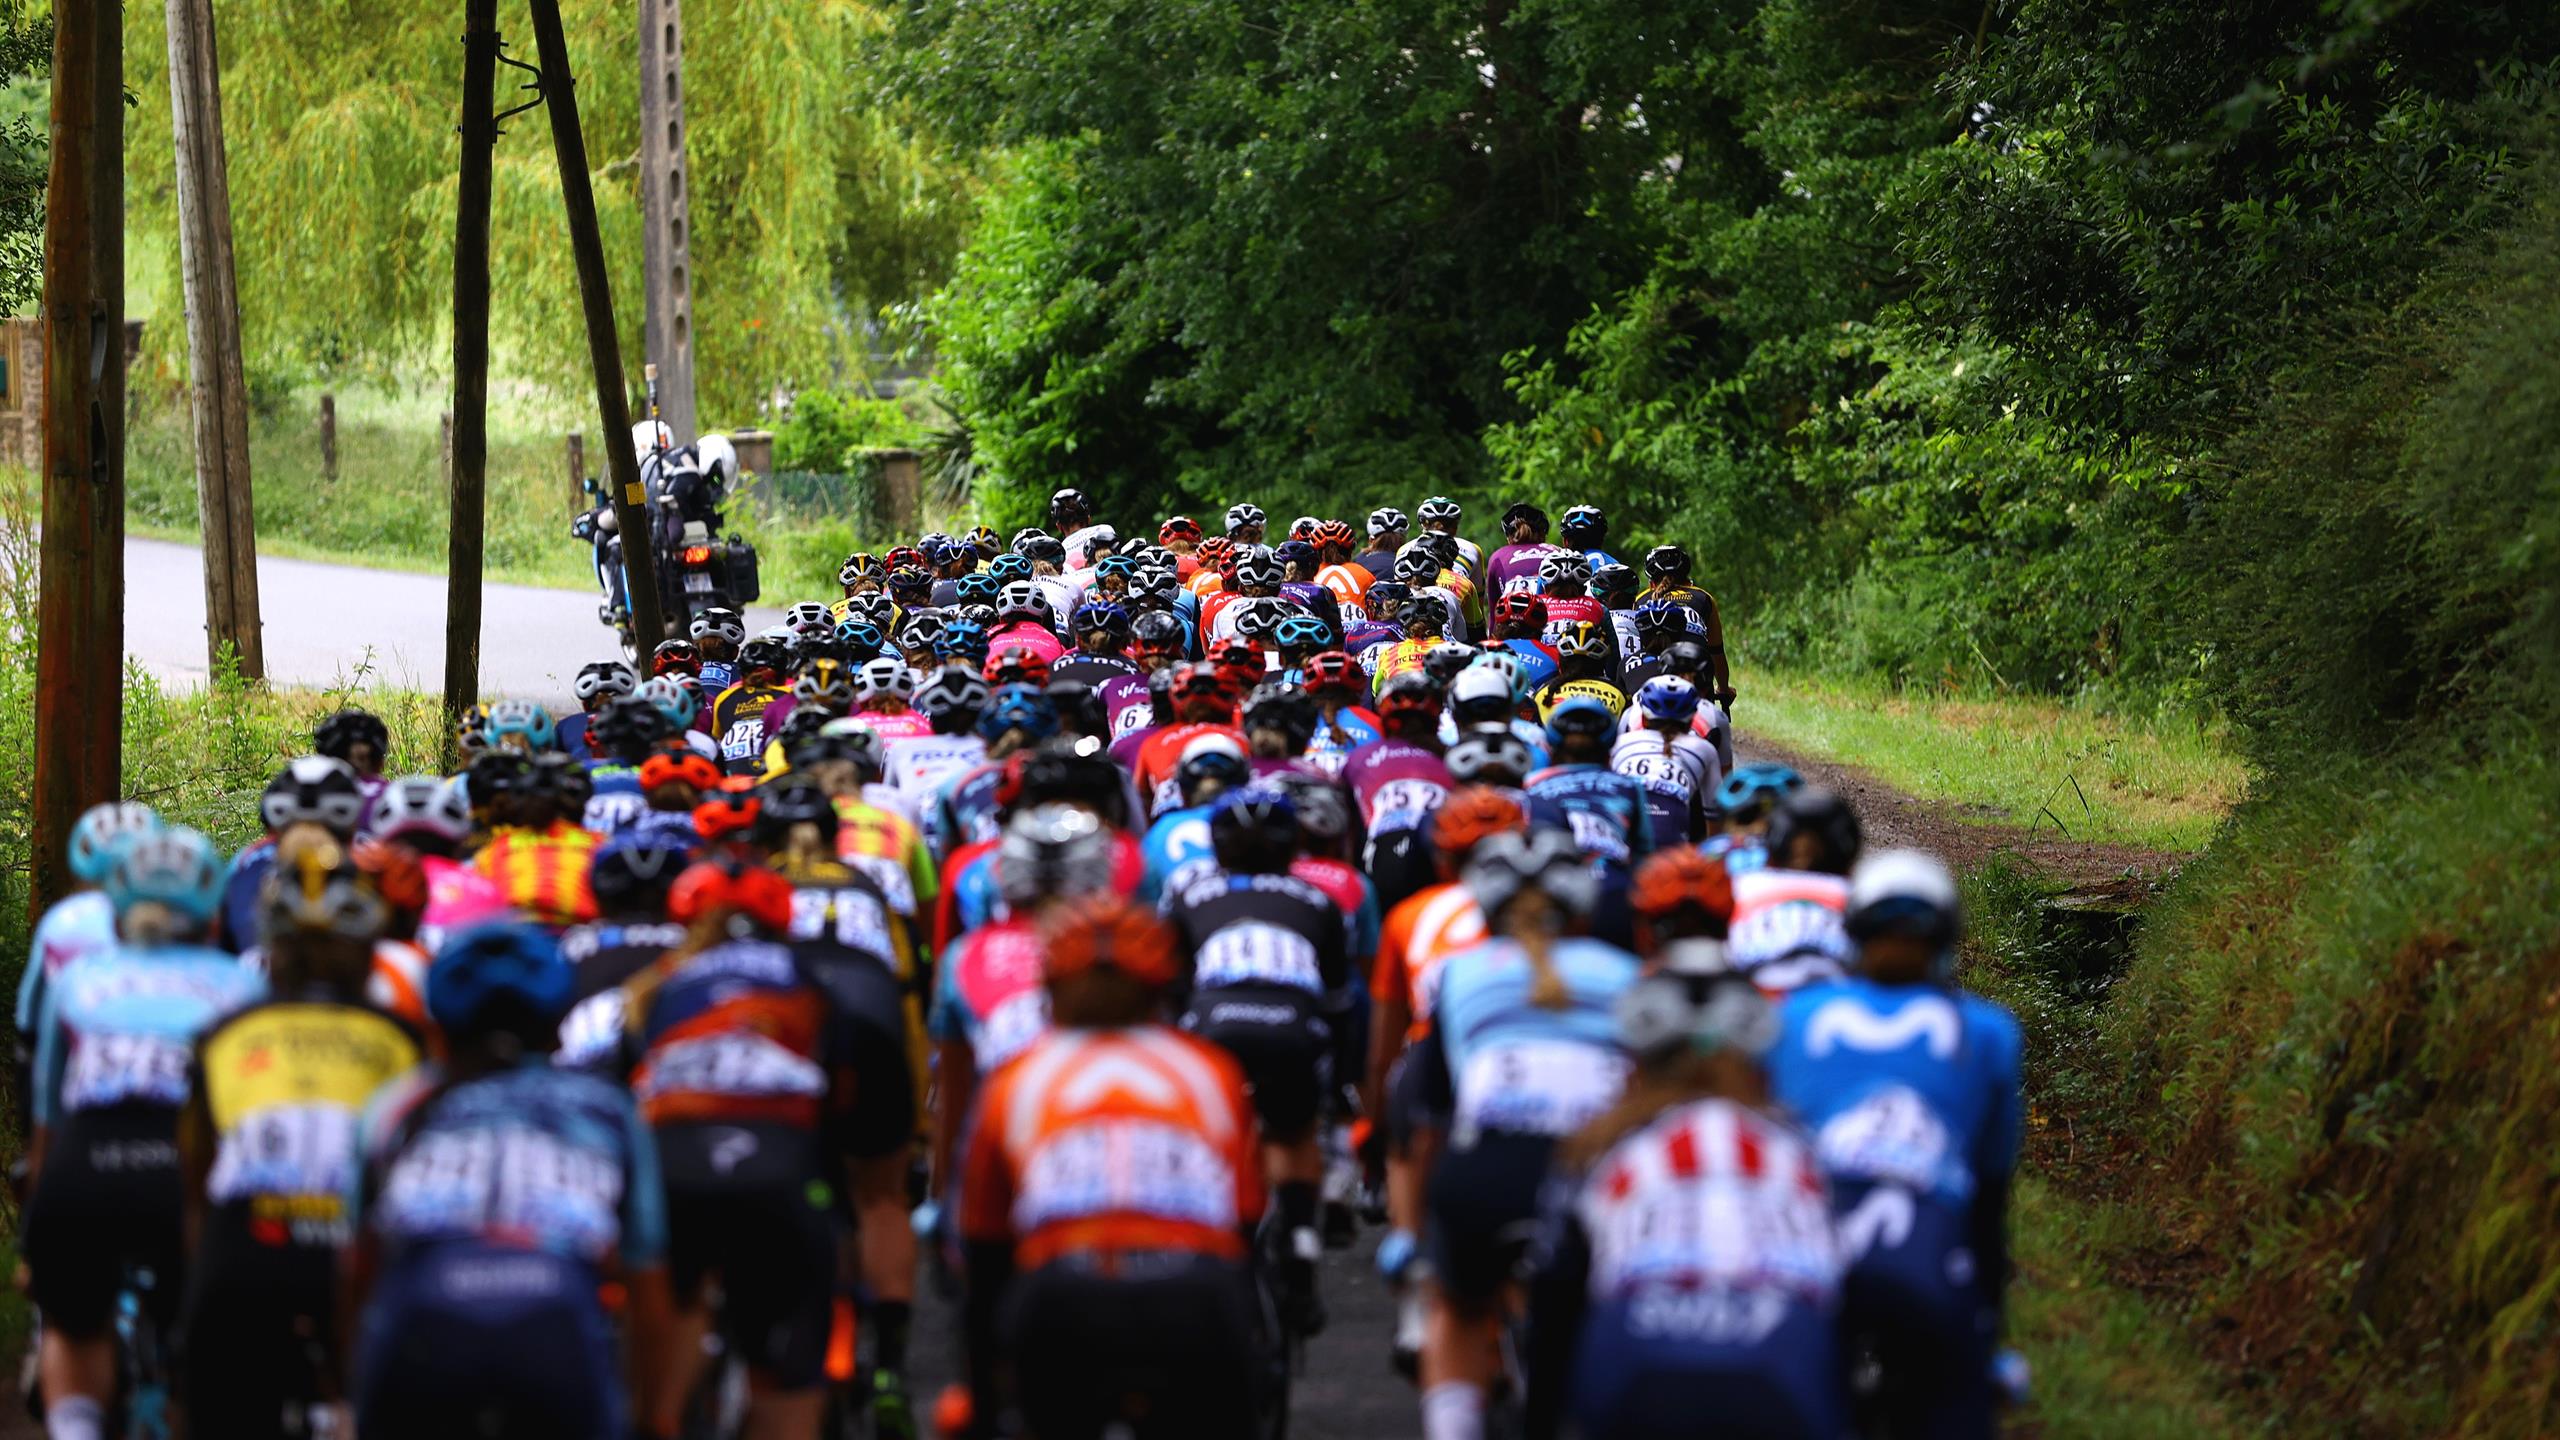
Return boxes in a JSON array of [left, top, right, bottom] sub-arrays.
[[33, 945, 266, 1125]]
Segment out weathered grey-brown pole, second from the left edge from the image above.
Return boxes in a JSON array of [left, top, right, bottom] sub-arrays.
[[169, 0, 266, 679]]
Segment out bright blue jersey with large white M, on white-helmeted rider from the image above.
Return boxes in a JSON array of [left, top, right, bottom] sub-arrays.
[[1769, 979, 2025, 1204]]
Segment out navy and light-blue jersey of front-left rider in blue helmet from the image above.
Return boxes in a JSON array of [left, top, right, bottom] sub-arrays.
[[348, 1061, 666, 1273]]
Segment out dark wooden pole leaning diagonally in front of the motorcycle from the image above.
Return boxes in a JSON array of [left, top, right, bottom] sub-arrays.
[[527, 0, 666, 659]]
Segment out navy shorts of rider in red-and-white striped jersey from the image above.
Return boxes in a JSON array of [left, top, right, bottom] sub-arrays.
[[1569, 1294, 1853, 1440]]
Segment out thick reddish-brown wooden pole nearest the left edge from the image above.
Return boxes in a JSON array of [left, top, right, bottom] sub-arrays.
[[31, 0, 125, 912]]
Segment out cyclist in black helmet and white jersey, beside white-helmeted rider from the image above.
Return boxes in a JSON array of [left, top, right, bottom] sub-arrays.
[[1725, 787, 1859, 994]]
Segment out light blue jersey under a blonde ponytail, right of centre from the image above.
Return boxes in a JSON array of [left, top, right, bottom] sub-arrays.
[[1431, 938, 1636, 1148]]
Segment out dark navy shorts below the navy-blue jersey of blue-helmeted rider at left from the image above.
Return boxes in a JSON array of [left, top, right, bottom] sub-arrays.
[[353, 1240, 625, 1440]]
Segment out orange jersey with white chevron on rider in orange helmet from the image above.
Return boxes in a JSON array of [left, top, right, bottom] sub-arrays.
[[960, 1025, 1262, 1271]]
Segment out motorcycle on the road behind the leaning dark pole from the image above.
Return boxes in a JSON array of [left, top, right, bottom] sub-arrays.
[[568, 423, 763, 666]]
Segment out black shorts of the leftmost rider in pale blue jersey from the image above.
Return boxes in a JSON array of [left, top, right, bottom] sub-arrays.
[[20, 1104, 187, 1340]]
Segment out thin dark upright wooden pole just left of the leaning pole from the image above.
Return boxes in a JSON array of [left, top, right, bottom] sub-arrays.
[[445, 0, 499, 733]]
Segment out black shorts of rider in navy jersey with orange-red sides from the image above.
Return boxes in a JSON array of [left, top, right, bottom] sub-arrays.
[[658, 1125, 837, 1391]]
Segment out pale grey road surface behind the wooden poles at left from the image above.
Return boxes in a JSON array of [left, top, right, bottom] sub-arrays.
[[125, 541, 781, 702]]
